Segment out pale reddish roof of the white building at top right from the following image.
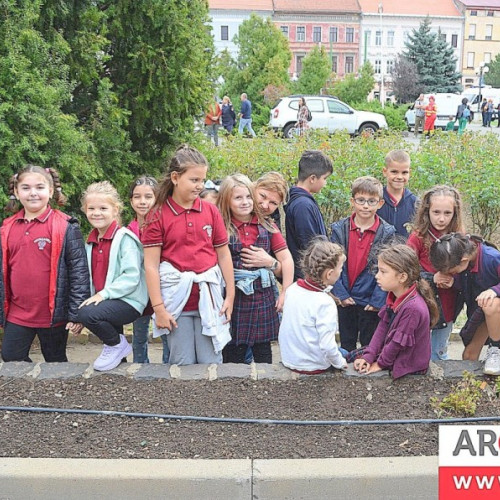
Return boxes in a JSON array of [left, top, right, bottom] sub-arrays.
[[358, 0, 461, 17]]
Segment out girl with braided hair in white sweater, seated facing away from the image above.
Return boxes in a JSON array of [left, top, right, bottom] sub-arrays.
[[279, 237, 347, 375]]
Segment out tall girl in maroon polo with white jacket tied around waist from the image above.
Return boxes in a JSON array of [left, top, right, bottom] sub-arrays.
[[142, 145, 234, 365]]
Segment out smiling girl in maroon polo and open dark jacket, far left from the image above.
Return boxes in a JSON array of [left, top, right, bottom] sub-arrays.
[[0, 165, 90, 362]]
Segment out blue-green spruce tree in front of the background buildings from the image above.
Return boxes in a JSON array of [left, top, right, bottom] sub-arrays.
[[403, 17, 461, 92]]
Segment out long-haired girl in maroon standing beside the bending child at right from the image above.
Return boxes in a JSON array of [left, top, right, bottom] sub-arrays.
[[407, 186, 463, 361]]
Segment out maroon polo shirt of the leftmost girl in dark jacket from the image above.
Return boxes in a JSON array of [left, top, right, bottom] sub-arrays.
[[7, 207, 53, 328]]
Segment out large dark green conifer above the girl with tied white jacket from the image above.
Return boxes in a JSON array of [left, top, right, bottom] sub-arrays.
[[37, 0, 213, 173]]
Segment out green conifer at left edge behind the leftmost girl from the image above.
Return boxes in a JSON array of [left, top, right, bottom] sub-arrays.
[[0, 0, 97, 215]]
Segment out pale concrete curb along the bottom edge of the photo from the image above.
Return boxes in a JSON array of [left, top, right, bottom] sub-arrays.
[[0, 457, 438, 500]]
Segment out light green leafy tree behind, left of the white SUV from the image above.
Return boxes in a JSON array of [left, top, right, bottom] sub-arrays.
[[221, 14, 292, 125]]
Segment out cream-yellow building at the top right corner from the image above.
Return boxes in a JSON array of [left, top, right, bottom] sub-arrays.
[[458, 0, 500, 88]]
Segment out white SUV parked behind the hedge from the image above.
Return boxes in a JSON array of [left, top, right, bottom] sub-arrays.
[[269, 95, 387, 137]]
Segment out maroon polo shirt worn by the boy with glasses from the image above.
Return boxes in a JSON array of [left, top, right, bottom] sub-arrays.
[[347, 214, 380, 288]]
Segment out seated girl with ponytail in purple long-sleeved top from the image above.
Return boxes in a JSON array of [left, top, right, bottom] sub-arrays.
[[354, 245, 439, 379]]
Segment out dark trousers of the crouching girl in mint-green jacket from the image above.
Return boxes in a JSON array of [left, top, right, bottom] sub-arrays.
[[78, 299, 141, 346]]
